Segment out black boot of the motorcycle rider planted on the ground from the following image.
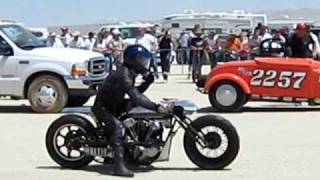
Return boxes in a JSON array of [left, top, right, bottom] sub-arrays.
[[113, 147, 134, 177]]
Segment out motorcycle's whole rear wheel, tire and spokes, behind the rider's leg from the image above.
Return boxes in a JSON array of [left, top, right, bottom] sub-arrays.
[[46, 116, 94, 168]]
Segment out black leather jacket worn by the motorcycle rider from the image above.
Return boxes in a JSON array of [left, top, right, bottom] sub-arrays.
[[96, 67, 158, 115]]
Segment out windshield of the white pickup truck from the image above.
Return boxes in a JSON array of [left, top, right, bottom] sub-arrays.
[[0, 25, 45, 50]]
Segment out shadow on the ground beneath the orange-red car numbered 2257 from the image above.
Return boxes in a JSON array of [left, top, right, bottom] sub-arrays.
[[197, 106, 320, 113]]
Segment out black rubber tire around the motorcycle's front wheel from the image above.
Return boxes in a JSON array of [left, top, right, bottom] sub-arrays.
[[184, 116, 240, 170]]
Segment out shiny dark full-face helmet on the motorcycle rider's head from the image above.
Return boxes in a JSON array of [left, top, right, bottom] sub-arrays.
[[123, 45, 151, 74]]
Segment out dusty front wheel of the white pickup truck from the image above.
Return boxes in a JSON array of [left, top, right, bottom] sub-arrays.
[[28, 75, 68, 113]]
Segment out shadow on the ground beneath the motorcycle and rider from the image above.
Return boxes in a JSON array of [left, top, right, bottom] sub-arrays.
[[36, 165, 231, 175]]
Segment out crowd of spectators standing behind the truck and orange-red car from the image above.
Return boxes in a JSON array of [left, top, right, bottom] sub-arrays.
[[47, 24, 320, 81]]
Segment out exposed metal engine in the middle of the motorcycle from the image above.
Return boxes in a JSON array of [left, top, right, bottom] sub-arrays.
[[124, 119, 164, 165]]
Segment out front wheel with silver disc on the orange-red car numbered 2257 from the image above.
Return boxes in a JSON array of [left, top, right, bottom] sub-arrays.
[[209, 81, 246, 112]]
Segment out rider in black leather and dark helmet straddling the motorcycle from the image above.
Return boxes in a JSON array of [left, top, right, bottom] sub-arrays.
[[92, 45, 168, 177]]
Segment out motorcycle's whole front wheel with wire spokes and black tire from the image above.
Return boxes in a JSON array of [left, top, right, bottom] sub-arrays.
[[184, 116, 239, 170]]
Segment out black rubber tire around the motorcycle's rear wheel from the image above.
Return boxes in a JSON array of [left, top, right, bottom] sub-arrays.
[[46, 115, 94, 169]]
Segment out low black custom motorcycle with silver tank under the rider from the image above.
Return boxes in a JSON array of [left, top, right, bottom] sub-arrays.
[[46, 99, 239, 170]]
